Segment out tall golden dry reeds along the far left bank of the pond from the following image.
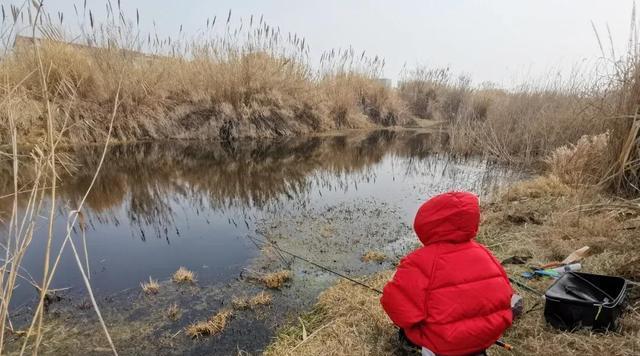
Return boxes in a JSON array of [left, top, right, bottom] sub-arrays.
[[0, 6, 404, 144]]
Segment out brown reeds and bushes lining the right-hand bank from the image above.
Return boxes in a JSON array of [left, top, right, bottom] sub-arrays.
[[398, 46, 640, 195]]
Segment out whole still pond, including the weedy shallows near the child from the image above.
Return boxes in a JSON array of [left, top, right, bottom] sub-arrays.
[[0, 130, 522, 354]]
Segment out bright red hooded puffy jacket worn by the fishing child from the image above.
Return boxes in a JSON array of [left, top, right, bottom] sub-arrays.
[[381, 192, 512, 355]]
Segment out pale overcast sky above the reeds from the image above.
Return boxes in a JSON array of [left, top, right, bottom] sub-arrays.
[[2, 0, 633, 86]]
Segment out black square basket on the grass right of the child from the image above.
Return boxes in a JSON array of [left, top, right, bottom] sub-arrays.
[[544, 272, 627, 331]]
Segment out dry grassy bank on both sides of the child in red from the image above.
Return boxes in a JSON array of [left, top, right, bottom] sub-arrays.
[[266, 177, 640, 356]]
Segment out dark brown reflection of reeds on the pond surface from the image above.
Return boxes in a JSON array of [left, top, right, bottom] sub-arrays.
[[0, 130, 488, 245]]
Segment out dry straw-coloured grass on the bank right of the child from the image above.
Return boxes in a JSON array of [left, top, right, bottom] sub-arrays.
[[480, 177, 640, 355]]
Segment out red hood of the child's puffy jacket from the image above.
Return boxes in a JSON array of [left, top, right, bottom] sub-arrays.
[[413, 192, 480, 245]]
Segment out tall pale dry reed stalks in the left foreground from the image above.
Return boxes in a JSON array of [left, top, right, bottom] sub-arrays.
[[0, 1, 119, 354]]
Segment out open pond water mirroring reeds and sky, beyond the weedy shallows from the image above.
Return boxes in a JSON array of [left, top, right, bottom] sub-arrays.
[[0, 130, 511, 304]]
